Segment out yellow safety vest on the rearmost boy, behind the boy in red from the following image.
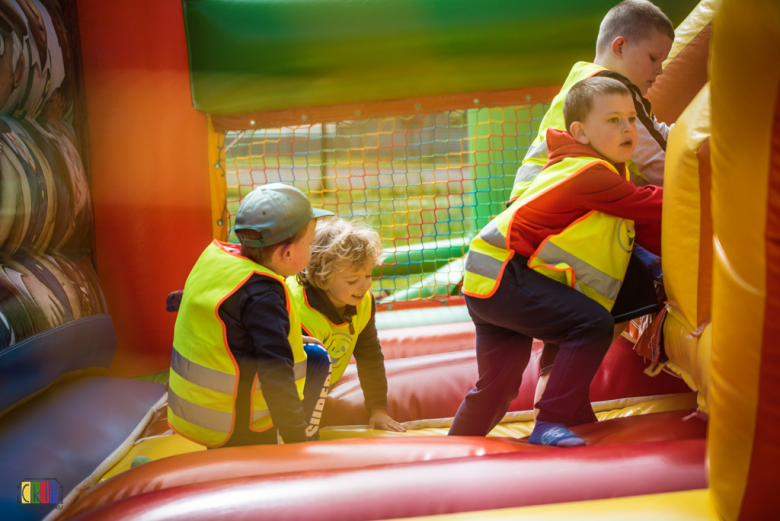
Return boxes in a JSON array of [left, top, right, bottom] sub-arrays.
[[509, 62, 607, 201]]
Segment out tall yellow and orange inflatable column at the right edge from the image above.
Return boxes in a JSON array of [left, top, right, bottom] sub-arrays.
[[708, 0, 780, 520]]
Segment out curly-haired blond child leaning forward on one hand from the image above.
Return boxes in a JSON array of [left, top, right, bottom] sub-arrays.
[[287, 219, 405, 432]]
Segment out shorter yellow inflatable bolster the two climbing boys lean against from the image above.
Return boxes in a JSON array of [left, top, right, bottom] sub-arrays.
[[662, 84, 712, 411]]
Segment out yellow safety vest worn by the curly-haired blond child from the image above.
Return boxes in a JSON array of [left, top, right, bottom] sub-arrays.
[[287, 277, 373, 388]]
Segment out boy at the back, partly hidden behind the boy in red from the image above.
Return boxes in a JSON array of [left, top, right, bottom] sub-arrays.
[[510, 0, 674, 420]]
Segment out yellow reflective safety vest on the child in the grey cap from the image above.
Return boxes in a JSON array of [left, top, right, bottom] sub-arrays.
[[168, 240, 306, 447]]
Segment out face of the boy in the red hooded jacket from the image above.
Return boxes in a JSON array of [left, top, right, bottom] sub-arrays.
[[569, 94, 637, 163]]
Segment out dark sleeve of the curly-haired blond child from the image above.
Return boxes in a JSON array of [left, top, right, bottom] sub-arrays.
[[354, 299, 387, 410]]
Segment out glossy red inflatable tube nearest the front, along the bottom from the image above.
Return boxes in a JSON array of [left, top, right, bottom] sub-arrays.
[[75, 439, 707, 521]]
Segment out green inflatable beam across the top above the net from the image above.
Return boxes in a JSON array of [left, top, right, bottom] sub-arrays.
[[183, 0, 698, 115]]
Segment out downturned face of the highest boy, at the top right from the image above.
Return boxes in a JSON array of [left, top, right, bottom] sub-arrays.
[[612, 31, 672, 96]]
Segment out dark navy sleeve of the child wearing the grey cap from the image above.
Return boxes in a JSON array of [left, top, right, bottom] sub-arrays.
[[241, 291, 306, 443]]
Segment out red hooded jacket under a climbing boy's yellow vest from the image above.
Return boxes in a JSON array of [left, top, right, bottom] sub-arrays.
[[509, 129, 663, 257]]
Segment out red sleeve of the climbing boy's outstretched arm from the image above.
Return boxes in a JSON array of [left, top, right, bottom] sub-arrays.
[[567, 165, 664, 255]]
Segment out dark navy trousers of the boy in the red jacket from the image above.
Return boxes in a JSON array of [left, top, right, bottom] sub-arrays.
[[449, 255, 615, 436]]
